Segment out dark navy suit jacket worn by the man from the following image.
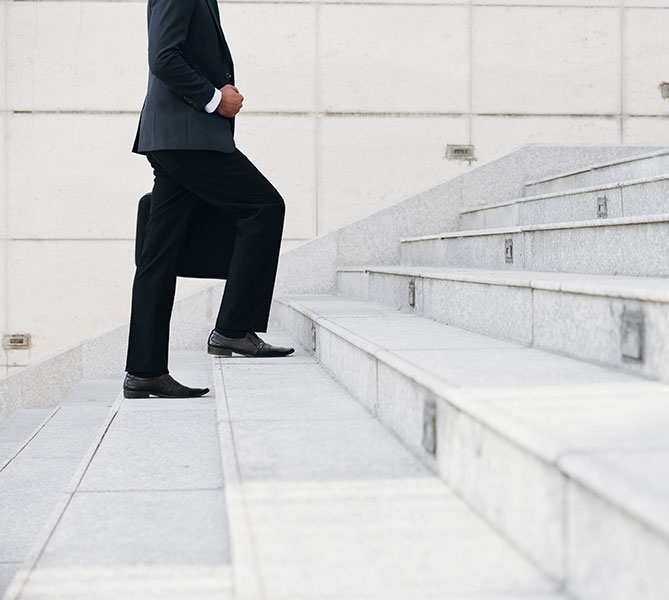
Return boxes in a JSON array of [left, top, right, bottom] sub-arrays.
[[132, 0, 235, 154]]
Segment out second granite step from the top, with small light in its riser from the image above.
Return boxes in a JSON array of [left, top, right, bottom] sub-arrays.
[[461, 175, 669, 230]]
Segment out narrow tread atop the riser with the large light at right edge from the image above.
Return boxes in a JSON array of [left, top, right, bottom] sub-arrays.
[[337, 265, 669, 303]]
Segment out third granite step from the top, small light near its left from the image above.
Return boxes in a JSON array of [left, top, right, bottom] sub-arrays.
[[400, 214, 669, 277]]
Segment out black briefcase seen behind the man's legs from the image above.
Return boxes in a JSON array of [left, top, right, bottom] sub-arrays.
[[135, 193, 237, 279]]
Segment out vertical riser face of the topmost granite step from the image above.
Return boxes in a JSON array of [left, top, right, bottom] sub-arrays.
[[525, 155, 669, 196]]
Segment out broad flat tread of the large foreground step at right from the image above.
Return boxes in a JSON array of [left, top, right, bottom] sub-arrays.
[[278, 295, 669, 536]]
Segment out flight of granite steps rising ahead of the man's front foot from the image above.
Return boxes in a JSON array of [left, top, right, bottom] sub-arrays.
[[275, 149, 669, 600]]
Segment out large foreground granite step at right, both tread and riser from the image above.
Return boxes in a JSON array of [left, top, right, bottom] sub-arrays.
[[270, 295, 669, 600]]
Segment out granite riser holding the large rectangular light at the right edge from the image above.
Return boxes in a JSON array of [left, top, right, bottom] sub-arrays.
[[338, 272, 669, 381]]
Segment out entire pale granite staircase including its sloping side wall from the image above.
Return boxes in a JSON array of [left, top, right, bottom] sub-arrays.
[[0, 146, 669, 600]]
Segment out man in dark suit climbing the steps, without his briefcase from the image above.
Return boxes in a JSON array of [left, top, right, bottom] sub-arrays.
[[123, 0, 294, 398]]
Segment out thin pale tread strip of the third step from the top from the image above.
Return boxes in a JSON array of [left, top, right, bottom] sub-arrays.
[[400, 213, 669, 243]]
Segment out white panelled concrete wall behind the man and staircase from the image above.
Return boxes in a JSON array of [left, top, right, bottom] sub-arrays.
[[0, 0, 669, 374]]
